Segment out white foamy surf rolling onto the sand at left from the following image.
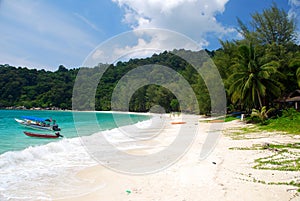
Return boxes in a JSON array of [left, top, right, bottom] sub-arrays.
[[0, 120, 151, 201]]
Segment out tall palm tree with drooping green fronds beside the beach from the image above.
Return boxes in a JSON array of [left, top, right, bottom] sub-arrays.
[[229, 43, 281, 109]]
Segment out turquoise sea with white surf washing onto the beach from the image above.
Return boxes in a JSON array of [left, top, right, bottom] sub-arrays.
[[0, 110, 151, 201]]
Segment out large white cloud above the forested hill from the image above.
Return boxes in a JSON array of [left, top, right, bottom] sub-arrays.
[[105, 0, 238, 62]]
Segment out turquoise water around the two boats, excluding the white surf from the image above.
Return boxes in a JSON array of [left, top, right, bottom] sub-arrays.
[[0, 110, 149, 154]]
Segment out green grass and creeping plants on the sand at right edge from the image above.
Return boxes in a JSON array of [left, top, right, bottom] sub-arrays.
[[225, 111, 300, 192]]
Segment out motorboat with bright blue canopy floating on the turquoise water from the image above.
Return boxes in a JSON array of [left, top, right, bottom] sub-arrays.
[[15, 116, 61, 131]]
